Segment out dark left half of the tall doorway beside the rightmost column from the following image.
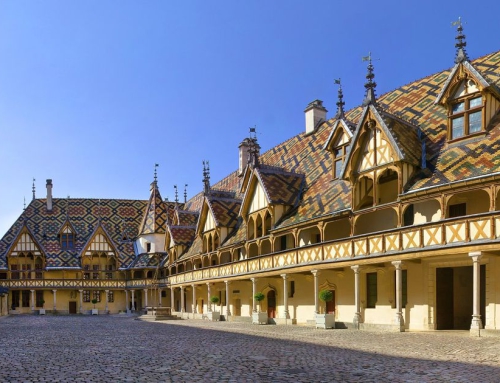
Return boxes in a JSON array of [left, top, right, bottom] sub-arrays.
[[436, 267, 454, 330]]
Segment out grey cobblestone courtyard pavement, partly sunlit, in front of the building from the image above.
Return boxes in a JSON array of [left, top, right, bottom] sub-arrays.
[[0, 316, 500, 383]]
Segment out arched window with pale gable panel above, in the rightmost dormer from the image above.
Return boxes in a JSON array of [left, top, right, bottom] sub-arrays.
[[449, 80, 484, 140]]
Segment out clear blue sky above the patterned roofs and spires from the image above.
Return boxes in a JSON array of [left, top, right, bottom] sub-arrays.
[[0, 0, 500, 236]]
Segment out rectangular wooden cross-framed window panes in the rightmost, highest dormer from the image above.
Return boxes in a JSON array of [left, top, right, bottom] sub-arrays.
[[450, 91, 483, 140]]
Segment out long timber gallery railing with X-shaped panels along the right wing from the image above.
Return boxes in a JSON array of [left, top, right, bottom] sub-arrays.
[[169, 212, 500, 285]]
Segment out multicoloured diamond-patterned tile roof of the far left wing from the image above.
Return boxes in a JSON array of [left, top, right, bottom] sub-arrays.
[[0, 198, 147, 268]]
